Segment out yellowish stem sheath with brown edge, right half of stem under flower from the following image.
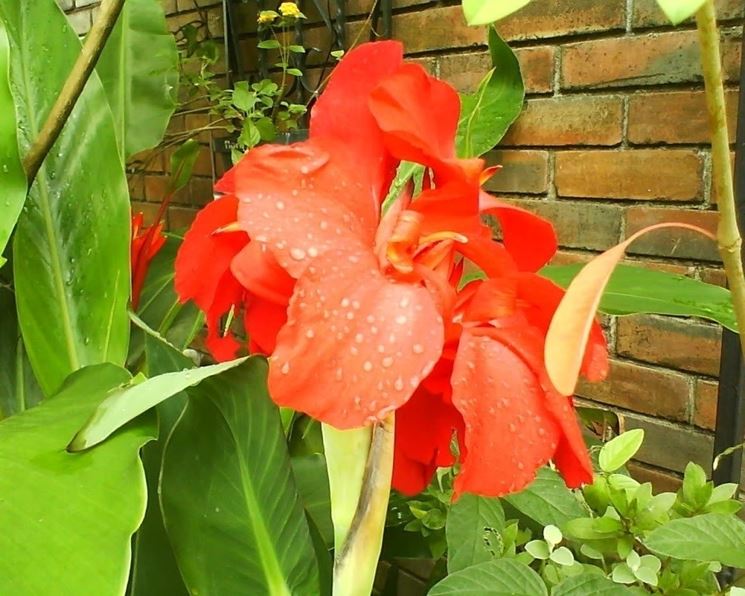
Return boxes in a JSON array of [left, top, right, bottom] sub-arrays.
[[333, 414, 395, 596]]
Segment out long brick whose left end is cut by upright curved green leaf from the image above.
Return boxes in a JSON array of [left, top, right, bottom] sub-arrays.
[[502, 95, 623, 147]]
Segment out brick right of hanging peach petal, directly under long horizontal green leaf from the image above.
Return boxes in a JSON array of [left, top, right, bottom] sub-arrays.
[[616, 315, 722, 376]]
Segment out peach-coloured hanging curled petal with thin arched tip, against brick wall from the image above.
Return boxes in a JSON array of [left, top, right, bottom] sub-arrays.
[[545, 223, 711, 395]]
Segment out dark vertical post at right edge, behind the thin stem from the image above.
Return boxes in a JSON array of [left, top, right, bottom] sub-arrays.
[[712, 28, 745, 484]]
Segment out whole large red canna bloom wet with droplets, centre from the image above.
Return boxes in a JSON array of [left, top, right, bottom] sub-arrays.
[[177, 42, 607, 495]]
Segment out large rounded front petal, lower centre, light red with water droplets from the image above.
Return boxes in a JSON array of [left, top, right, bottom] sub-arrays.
[[269, 246, 443, 429]]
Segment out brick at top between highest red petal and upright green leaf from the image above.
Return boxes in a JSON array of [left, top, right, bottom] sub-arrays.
[[386, 6, 486, 54]]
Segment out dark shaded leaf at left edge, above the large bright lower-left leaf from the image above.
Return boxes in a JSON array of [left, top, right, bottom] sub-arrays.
[[0, 287, 44, 420]]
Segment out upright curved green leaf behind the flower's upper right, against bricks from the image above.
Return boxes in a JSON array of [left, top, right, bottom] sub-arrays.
[[456, 27, 525, 157]]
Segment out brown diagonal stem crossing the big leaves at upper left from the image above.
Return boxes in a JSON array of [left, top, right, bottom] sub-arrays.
[[23, 0, 124, 188]]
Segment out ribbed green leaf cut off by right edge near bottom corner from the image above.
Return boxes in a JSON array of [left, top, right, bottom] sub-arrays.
[[644, 513, 745, 568]]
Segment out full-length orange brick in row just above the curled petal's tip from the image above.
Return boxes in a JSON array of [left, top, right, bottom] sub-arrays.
[[555, 149, 704, 201]]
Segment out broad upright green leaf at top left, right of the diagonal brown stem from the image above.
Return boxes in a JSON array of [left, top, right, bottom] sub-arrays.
[[96, 0, 179, 160]]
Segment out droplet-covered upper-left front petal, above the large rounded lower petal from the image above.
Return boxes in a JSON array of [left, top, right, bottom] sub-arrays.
[[236, 140, 379, 279]]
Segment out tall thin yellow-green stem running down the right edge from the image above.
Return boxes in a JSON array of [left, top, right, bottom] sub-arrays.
[[696, 0, 745, 354]]
